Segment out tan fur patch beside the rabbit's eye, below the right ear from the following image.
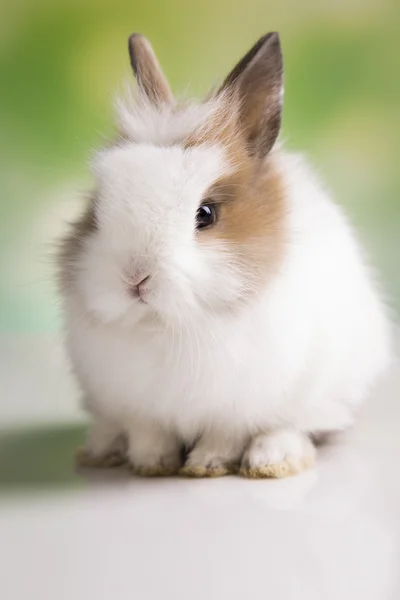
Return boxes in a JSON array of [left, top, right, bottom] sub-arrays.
[[184, 96, 285, 300]]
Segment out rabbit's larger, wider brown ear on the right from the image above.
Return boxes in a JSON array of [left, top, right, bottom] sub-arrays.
[[219, 33, 283, 158]]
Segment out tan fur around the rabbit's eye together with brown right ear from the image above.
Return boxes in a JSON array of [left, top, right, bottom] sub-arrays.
[[185, 33, 285, 291]]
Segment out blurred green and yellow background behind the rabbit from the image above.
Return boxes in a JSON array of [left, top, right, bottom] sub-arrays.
[[0, 0, 400, 334]]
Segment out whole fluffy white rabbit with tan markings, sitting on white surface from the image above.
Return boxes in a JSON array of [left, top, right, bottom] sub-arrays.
[[59, 33, 392, 478]]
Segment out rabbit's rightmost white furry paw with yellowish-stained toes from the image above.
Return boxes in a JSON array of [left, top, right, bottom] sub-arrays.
[[240, 430, 315, 479]]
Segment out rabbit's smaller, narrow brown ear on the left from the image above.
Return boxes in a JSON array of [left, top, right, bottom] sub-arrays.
[[128, 33, 174, 104]]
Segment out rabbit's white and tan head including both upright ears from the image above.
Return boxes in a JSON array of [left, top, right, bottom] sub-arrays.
[[63, 33, 284, 322]]
